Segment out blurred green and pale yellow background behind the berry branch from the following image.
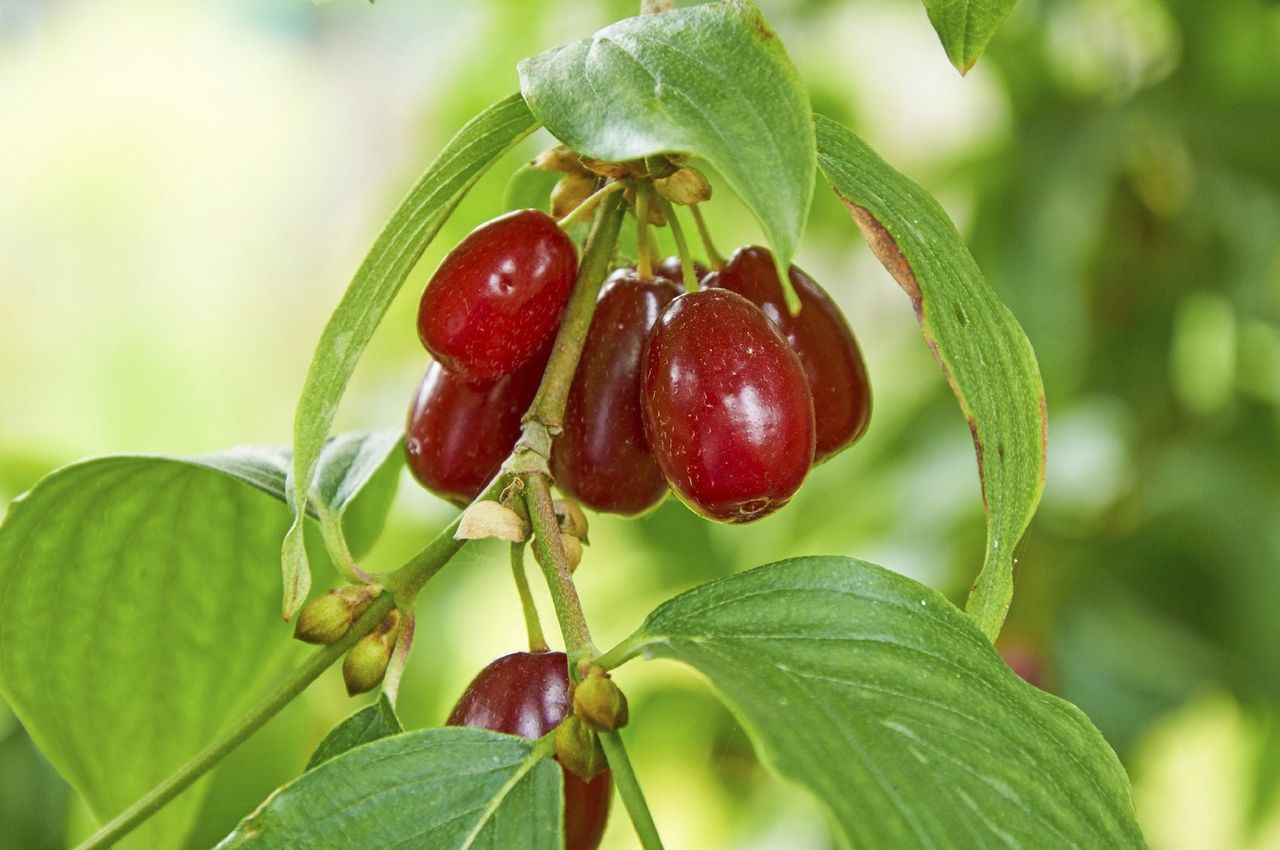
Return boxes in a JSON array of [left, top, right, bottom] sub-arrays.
[[0, 0, 1280, 850]]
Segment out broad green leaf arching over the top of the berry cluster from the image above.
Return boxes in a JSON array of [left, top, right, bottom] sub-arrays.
[[520, 0, 815, 268]]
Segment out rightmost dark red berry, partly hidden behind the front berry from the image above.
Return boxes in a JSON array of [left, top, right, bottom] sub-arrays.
[[704, 241, 872, 463]]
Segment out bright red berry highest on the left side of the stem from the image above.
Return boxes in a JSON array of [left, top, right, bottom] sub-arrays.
[[417, 210, 577, 383]]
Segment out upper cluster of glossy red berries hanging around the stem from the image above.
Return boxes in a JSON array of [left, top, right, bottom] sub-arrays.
[[406, 166, 870, 522]]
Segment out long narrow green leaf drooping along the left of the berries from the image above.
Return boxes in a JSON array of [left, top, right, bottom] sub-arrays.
[[280, 95, 538, 618]]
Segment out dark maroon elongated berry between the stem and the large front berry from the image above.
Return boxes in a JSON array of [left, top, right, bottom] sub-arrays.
[[552, 269, 680, 516]]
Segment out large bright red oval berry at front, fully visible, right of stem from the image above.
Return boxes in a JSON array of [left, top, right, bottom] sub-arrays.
[[643, 289, 814, 522]]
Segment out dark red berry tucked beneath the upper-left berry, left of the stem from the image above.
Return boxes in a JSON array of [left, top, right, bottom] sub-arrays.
[[404, 346, 550, 506]]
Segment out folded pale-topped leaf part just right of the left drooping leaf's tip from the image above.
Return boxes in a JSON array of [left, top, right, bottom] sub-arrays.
[[311, 431, 404, 573]]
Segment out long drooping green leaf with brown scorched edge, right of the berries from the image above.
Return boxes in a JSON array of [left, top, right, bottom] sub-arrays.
[[815, 115, 1047, 640]]
